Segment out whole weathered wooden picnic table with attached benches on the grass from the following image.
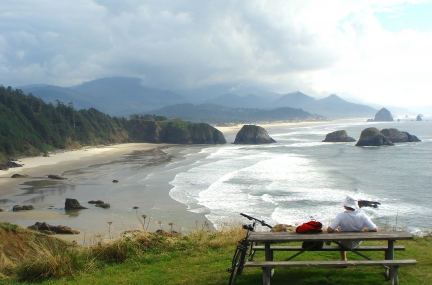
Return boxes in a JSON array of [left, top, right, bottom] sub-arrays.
[[245, 231, 417, 285]]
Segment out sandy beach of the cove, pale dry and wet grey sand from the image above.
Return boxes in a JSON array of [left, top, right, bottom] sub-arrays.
[[0, 118, 350, 242]]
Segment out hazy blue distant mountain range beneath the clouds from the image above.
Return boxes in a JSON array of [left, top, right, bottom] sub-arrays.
[[17, 77, 377, 118]]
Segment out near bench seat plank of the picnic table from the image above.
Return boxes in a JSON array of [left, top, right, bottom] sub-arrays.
[[245, 259, 417, 268]]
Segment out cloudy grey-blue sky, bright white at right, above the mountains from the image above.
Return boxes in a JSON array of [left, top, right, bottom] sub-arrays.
[[0, 0, 432, 110]]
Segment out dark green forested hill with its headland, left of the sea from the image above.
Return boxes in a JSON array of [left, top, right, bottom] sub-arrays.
[[0, 85, 225, 162]]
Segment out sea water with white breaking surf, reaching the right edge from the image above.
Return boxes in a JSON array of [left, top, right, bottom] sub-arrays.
[[169, 118, 432, 232]]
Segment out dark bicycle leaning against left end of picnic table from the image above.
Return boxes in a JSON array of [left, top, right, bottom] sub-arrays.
[[227, 213, 272, 285]]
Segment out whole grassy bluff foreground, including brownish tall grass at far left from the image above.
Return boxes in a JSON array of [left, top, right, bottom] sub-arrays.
[[0, 223, 432, 285]]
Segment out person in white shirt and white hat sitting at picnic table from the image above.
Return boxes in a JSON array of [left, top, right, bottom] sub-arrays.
[[327, 196, 378, 261]]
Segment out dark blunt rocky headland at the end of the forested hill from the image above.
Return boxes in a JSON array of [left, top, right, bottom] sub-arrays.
[[128, 120, 226, 144]]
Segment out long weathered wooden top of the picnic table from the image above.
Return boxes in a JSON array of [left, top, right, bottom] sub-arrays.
[[248, 231, 413, 243]]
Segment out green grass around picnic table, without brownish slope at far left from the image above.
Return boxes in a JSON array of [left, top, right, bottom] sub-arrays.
[[0, 223, 432, 285]]
